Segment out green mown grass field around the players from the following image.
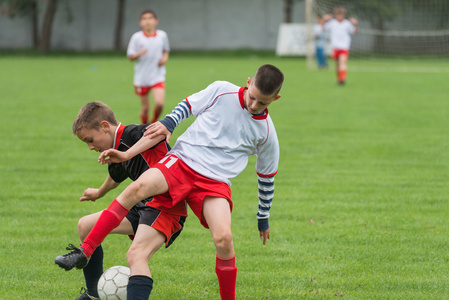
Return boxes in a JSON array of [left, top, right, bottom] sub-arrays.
[[0, 53, 449, 300]]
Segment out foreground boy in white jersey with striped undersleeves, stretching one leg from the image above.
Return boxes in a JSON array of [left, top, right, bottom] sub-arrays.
[[57, 65, 284, 299]]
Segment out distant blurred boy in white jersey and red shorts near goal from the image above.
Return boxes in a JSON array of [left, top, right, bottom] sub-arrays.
[[324, 7, 358, 85]]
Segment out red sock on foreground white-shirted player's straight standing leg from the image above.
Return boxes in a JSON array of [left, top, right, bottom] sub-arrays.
[[215, 256, 237, 300]]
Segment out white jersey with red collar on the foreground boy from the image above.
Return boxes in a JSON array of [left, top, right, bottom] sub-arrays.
[[169, 81, 279, 185]]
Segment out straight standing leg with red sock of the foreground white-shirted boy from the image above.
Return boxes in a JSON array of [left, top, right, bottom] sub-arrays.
[[203, 197, 237, 300]]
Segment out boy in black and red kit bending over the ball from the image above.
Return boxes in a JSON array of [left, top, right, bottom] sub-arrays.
[[55, 102, 187, 300]]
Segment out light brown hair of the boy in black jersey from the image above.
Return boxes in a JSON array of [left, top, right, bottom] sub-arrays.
[[72, 101, 118, 134]]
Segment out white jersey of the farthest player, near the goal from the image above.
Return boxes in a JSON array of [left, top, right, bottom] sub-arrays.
[[324, 19, 355, 50]]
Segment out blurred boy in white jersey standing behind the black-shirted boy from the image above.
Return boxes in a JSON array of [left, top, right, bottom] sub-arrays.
[[126, 10, 170, 124]]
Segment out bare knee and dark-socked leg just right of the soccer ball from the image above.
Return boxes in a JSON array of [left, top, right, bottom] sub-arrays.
[[126, 224, 166, 300]]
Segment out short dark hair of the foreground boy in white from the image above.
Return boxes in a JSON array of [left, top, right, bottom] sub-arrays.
[[252, 65, 284, 96]]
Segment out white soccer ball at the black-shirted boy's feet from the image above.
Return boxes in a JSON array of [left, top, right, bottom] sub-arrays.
[[97, 266, 131, 300]]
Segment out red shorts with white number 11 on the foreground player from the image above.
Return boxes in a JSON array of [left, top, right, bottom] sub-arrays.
[[153, 155, 232, 228]]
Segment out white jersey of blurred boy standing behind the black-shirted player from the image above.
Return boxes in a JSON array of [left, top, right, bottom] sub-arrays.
[[126, 30, 170, 86]]
